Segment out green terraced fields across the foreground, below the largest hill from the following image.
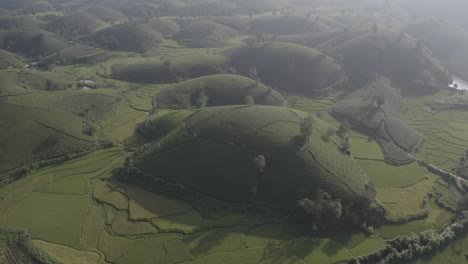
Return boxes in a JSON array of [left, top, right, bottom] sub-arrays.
[[0, 144, 385, 264]]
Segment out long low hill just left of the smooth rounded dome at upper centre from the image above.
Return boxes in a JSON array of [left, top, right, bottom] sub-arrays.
[[112, 54, 229, 83]]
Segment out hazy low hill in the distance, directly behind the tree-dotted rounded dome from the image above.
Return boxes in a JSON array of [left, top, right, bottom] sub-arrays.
[[250, 16, 331, 35]]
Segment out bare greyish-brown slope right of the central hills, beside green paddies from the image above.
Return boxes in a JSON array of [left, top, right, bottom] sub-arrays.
[[333, 77, 423, 164]]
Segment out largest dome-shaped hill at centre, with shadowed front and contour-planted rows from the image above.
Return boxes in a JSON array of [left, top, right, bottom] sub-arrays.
[[134, 106, 367, 205]]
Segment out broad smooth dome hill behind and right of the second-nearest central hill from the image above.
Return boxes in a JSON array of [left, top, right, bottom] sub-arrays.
[[232, 42, 343, 93]]
